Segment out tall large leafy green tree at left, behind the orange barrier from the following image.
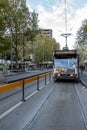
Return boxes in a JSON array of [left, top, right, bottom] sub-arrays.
[[0, 0, 38, 68]]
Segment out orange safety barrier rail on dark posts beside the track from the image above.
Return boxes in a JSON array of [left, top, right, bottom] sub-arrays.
[[0, 72, 52, 101]]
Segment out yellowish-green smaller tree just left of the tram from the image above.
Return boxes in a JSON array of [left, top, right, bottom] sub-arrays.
[[34, 32, 58, 64]]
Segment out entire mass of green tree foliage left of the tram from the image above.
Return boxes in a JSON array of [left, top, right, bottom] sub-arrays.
[[0, 0, 60, 66]]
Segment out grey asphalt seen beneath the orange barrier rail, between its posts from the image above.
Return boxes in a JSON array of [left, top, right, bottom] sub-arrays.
[[0, 77, 49, 114]]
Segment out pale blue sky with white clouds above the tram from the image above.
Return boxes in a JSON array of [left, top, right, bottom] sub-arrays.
[[26, 0, 87, 49]]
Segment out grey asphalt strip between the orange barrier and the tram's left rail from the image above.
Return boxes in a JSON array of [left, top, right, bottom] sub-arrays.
[[0, 80, 54, 130]]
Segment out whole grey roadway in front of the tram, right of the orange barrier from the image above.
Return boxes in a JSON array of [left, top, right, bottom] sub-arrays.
[[0, 70, 87, 130]]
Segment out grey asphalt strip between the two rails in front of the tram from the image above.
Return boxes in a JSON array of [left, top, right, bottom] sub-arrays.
[[28, 83, 86, 130]]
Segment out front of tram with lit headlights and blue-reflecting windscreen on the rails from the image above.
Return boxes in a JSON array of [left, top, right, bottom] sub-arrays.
[[53, 50, 79, 82]]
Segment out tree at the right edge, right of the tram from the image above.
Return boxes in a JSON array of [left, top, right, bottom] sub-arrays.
[[75, 19, 87, 62]]
